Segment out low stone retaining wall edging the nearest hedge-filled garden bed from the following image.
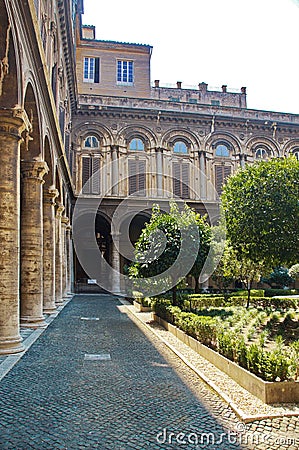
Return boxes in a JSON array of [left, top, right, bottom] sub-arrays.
[[153, 313, 299, 405]]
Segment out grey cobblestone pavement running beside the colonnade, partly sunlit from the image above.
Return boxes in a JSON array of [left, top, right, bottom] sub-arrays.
[[0, 295, 299, 450]]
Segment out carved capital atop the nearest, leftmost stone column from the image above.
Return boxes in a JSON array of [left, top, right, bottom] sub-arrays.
[[0, 105, 32, 139]]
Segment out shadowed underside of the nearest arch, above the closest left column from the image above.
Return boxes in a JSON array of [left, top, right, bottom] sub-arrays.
[[0, 0, 18, 108]]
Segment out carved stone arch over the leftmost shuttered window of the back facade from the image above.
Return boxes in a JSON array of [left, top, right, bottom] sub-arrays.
[[73, 122, 114, 147]]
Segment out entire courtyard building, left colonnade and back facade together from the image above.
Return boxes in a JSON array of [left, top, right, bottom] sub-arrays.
[[0, 0, 299, 354]]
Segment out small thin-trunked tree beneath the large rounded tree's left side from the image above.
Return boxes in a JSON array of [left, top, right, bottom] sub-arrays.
[[223, 242, 265, 308]]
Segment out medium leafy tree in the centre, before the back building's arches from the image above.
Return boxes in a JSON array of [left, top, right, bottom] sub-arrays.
[[129, 202, 210, 304]]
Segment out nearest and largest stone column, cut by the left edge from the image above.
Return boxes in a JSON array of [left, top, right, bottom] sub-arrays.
[[0, 107, 30, 355]]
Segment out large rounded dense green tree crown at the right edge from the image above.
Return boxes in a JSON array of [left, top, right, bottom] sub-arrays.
[[221, 157, 299, 268]]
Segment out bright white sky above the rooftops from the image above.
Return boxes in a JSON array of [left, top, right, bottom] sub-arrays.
[[82, 0, 299, 114]]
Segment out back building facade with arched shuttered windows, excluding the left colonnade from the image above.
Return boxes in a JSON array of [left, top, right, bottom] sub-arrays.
[[72, 22, 299, 289]]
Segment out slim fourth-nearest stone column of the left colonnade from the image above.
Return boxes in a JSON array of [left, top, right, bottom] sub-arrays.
[[55, 203, 64, 305]]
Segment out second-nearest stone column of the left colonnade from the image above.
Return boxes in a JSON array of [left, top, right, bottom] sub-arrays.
[[20, 160, 49, 328]]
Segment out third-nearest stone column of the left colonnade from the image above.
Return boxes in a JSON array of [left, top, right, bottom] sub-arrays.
[[43, 186, 58, 314]]
